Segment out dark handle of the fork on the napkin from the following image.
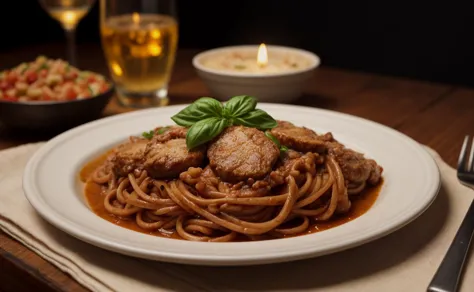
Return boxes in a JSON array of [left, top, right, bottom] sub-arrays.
[[427, 201, 474, 292]]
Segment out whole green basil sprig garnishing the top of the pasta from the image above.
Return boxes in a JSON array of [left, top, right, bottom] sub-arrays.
[[171, 95, 277, 149]]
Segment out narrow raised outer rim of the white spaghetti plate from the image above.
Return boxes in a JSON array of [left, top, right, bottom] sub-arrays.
[[22, 102, 441, 266]]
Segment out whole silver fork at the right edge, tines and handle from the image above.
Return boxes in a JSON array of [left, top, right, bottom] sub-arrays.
[[427, 136, 474, 292]]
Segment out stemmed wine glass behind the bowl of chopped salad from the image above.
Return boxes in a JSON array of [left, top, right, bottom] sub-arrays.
[[39, 0, 96, 66]]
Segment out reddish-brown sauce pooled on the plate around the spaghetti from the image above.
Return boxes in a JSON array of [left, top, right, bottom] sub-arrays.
[[79, 152, 383, 239]]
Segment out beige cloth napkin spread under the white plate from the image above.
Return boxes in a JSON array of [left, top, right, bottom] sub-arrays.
[[0, 143, 474, 292]]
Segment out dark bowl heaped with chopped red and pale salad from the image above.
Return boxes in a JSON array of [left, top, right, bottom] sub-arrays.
[[0, 56, 114, 130]]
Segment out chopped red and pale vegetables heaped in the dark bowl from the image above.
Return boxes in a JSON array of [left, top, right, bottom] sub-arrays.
[[0, 56, 111, 102]]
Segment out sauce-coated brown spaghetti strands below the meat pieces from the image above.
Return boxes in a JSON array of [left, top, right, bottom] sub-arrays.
[[89, 146, 378, 242]]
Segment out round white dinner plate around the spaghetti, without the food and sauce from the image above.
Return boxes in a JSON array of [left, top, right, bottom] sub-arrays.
[[23, 103, 440, 265]]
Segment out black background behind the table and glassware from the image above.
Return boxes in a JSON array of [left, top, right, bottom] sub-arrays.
[[0, 0, 474, 86]]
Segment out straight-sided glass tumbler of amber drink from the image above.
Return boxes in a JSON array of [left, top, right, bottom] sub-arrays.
[[100, 0, 178, 107]]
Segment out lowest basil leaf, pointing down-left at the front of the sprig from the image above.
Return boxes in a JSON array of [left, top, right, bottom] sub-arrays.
[[186, 117, 230, 150]]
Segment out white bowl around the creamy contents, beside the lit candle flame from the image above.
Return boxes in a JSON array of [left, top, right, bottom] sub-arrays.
[[193, 45, 320, 103]]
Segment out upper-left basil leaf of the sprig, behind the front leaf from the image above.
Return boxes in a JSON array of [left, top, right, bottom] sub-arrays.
[[171, 97, 222, 127]]
